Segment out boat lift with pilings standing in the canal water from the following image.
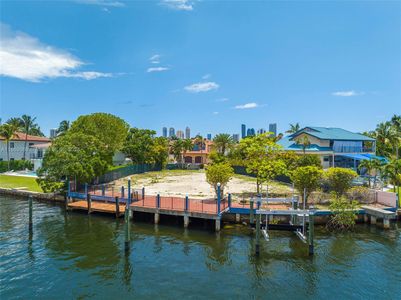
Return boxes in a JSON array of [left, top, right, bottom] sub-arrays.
[[250, 191, 314, 255]]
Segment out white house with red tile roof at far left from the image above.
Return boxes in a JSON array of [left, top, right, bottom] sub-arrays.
[[0, 132, 51, 169]]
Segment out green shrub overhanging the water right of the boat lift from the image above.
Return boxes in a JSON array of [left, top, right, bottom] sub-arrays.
[[327, 194, 359, 230]]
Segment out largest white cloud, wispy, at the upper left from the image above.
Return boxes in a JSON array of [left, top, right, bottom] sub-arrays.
[[0, 23, 112, 82]]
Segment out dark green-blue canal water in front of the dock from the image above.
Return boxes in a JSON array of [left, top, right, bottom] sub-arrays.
[[0, 196, 401, 300]]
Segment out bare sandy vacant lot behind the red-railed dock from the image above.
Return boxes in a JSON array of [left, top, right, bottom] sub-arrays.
[[116, 170, 290, 199]]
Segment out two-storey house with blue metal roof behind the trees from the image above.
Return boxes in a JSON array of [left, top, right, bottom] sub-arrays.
[[278, 126, 385, 171]]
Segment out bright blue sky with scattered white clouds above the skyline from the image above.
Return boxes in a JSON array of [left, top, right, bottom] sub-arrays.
[[0, 0, 401, 135]]
